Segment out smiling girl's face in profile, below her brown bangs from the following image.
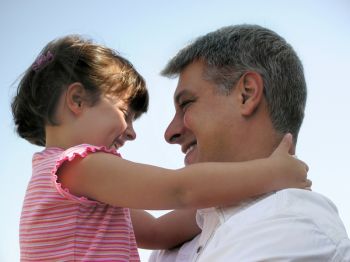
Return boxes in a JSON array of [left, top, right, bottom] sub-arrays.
[[79, 96, 136, 149]]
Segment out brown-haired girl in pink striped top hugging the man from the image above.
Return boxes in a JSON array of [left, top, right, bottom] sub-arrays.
[[12, 36, 310, 261]]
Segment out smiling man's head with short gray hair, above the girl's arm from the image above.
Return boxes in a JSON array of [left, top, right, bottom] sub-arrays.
[[162, 25, 306, 163]]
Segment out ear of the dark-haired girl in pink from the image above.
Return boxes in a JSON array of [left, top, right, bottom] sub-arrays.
[[66, 82, 86, 114]]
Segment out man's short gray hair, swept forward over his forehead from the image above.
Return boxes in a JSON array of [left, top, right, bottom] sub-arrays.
[[161, 25, 307, 141]]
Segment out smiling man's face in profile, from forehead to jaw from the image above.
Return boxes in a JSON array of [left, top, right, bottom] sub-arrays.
[[165, 61, 244, 165]]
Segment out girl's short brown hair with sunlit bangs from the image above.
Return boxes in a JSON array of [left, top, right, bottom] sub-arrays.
[[12, 35, 148, 146]]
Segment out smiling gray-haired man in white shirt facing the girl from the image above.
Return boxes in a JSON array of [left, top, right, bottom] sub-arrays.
[[151, 25, 350, 262]]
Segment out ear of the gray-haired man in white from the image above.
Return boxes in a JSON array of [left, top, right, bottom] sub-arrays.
[[236, 72, 264, 116]]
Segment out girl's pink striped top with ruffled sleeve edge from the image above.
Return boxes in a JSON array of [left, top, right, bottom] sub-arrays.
[[20, 145, 140, 261]]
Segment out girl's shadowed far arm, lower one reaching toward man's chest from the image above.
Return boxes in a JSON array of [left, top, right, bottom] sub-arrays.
[[130, 209, 201, 249]]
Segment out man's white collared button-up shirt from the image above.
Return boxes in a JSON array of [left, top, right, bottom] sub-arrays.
[[149, 189, 350, 262]]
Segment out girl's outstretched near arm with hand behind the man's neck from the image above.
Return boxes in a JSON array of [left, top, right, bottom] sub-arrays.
[[58, 135, 310, 209]]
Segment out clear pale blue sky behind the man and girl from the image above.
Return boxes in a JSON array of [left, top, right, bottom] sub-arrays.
[[0, 0, 350, 262]]
